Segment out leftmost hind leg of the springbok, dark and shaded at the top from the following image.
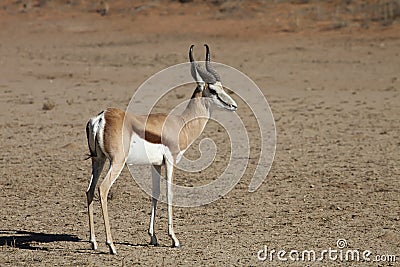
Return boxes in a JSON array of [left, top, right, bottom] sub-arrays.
[[86, 157, 106, 250]]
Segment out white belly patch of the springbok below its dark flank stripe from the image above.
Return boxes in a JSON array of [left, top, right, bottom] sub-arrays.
[[126, 134, 168, 165]]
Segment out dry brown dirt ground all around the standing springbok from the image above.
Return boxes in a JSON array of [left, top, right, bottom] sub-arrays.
[[0, 1, 400, 266]]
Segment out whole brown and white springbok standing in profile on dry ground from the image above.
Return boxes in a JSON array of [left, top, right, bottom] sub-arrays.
[[86, 45, 237, 254]]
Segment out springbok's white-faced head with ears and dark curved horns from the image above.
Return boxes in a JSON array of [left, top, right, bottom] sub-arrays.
[[189, 44, 237, 111]]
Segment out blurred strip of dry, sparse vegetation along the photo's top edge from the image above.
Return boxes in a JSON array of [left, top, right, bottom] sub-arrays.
[[0, 0, 400, 31]]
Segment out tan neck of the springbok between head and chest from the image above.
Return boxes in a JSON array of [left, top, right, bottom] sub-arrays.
[[181, 88, 210, 147]]
